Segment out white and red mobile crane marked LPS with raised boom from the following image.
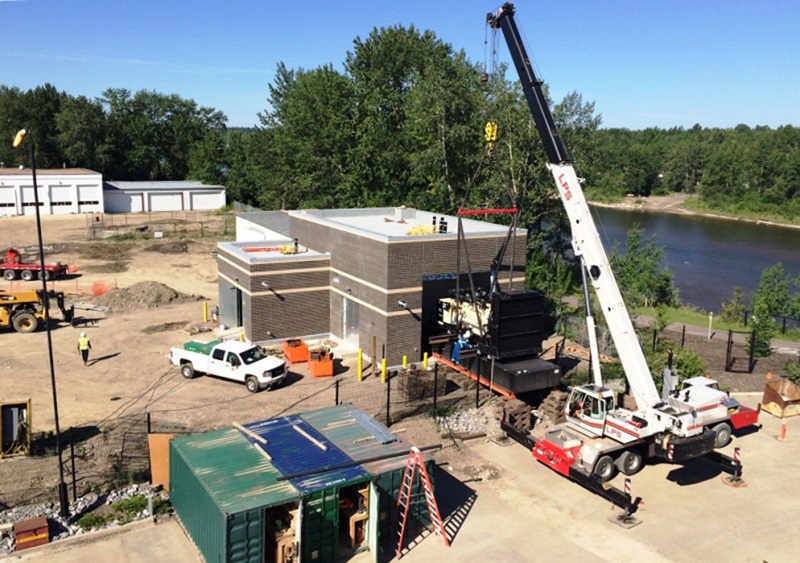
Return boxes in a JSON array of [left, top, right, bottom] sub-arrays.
[[487, 3, 752, 484]]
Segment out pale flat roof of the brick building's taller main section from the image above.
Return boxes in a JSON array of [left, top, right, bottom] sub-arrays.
[[287, 207, 525, 241]]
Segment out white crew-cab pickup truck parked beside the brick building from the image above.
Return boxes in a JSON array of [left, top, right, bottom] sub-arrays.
[[169, 340, 287, 393]]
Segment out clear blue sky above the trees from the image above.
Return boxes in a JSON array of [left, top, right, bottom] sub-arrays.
[[0, 0, 800, 129]]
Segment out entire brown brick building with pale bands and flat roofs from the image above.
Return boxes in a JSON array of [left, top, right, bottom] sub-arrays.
[[217, 208, 527, 364]]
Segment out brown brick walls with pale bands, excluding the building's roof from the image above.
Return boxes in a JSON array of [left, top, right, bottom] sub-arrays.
[[228, 216, 526, 365]]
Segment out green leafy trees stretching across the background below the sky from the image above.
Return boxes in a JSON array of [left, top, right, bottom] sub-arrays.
[[0, 26, 800, 318]]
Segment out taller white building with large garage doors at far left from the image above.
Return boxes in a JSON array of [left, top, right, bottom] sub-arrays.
[[0, 168, 103, 215]]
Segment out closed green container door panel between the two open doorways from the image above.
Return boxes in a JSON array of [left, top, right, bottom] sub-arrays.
[[301, 489, 339, 563]]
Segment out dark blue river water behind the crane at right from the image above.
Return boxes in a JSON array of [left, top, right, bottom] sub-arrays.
[[592, 207, 800, 313]]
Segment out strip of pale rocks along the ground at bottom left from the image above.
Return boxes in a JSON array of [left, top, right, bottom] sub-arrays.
[[0, 484, 159, 555]]
